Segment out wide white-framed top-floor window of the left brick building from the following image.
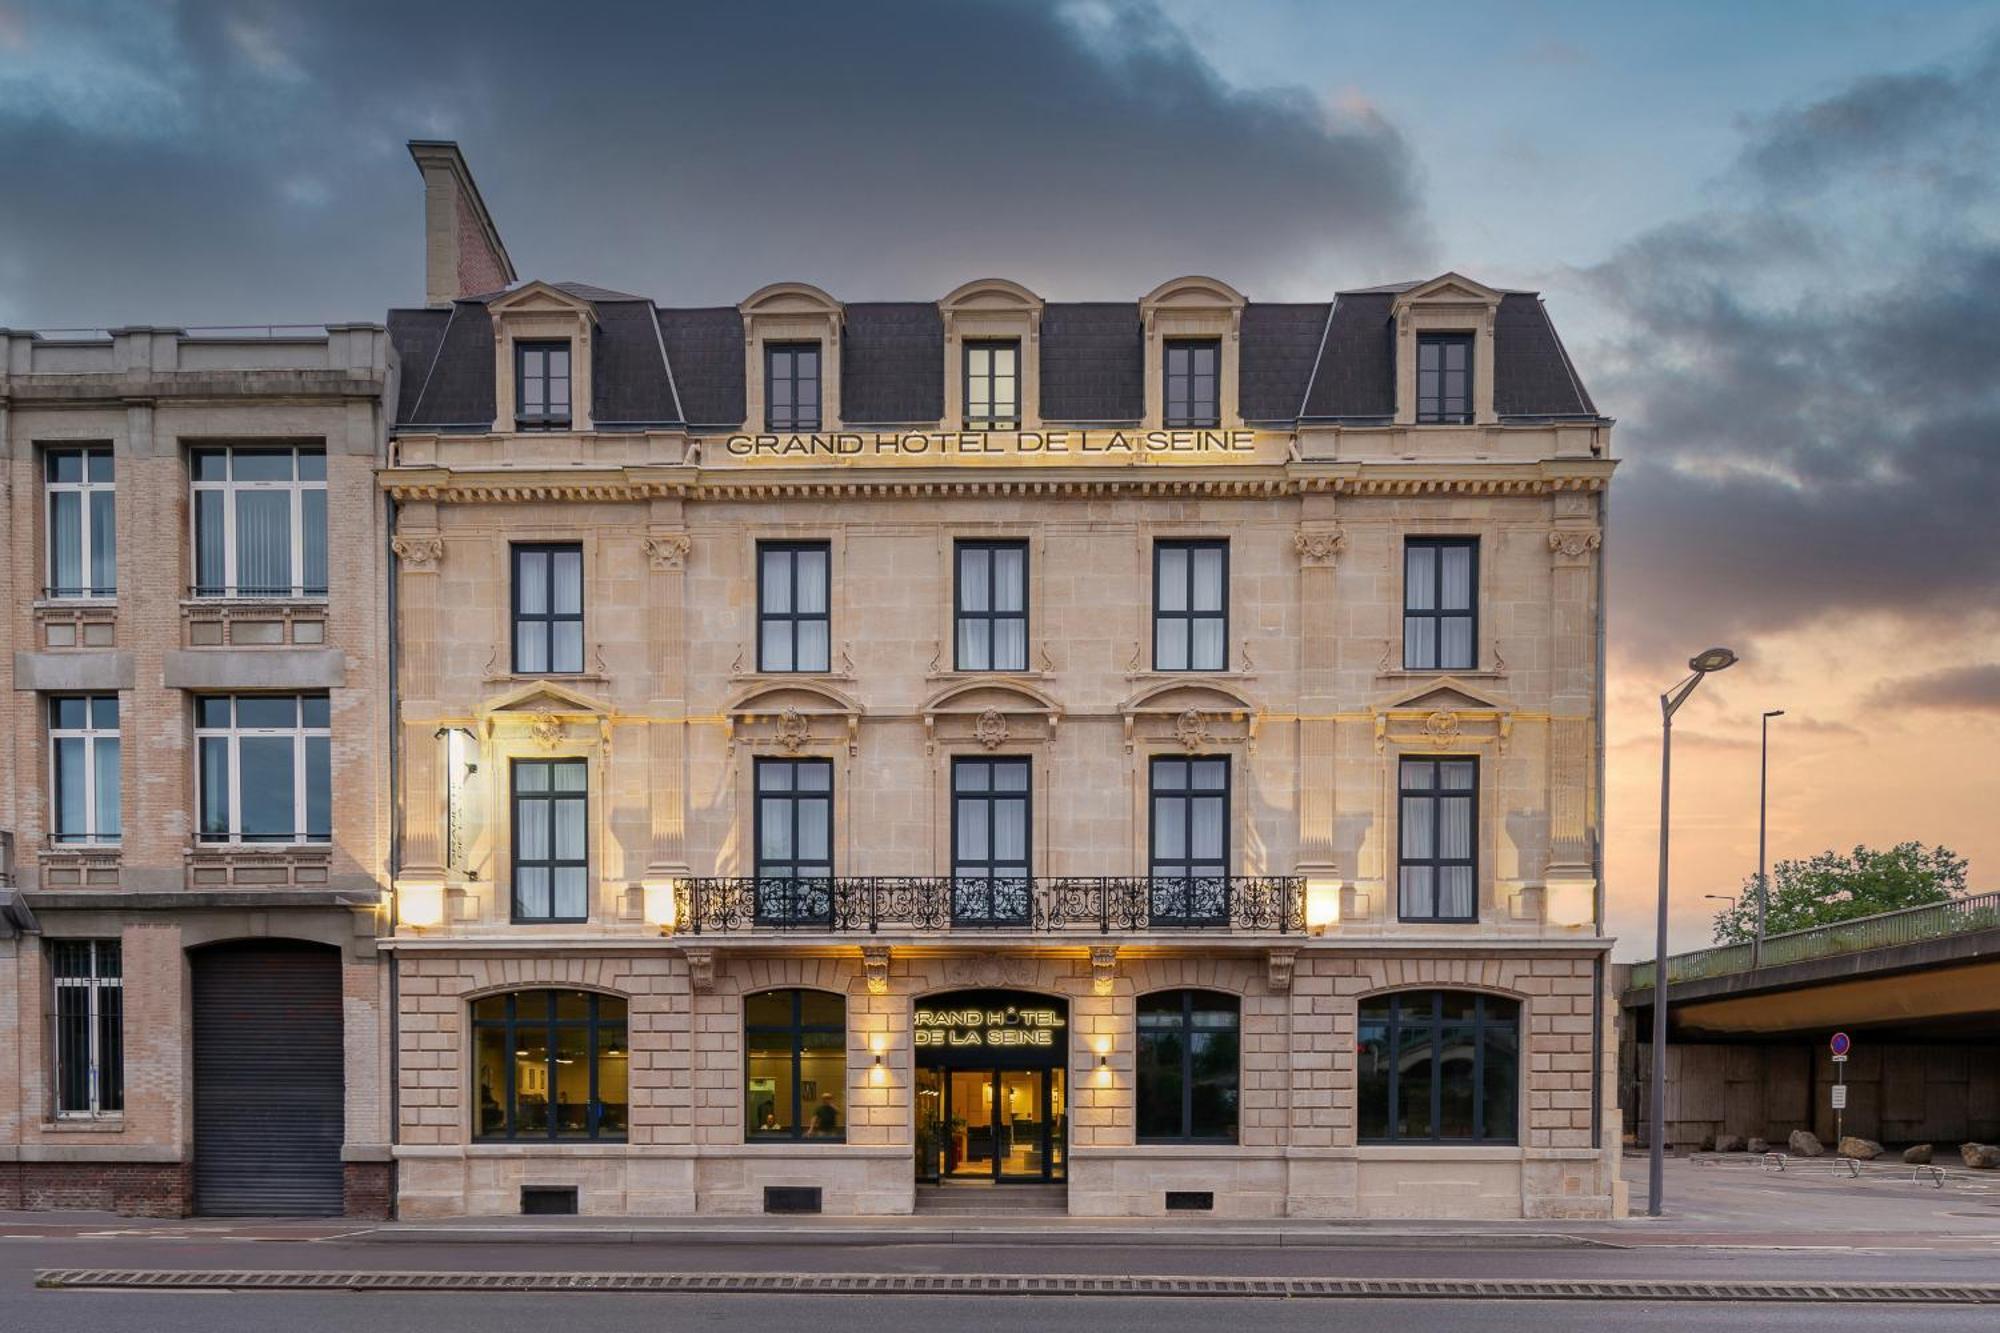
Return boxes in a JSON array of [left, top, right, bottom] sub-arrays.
[[188, 446, 326, 596]]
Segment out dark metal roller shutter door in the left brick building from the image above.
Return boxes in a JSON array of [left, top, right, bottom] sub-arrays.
[[192, 941, 344, 1217]]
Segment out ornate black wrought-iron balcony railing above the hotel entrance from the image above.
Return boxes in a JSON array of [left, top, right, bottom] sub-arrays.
[[676, 875, 1306, 935]]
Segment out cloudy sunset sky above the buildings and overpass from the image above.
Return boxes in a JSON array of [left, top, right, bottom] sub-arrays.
[[0, 0, 2000, 957]]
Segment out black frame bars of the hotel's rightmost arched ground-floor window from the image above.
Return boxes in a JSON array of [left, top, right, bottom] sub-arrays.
[[1354, 987, 1522, 1147]]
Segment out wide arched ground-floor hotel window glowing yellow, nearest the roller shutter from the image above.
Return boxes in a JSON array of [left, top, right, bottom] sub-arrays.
[[472, 991, 632, 1139]]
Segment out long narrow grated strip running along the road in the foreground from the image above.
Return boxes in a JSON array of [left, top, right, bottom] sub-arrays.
[[34, 1269, 2000, 1305]]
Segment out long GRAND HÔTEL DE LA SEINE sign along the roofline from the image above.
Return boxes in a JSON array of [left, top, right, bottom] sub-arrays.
[[722, 430, 1290, 466]]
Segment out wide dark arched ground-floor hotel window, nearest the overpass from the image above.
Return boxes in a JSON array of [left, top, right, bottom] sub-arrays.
[[1354, 991, 1520, 1143]]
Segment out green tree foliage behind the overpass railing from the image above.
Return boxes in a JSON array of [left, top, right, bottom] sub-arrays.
[[1714, 843, 1966, 945]]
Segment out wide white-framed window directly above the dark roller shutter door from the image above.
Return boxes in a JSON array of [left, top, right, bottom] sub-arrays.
[[194, 695, 334, 843]]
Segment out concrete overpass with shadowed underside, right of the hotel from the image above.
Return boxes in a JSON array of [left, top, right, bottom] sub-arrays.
[[1618, 893, 2000, 1147]]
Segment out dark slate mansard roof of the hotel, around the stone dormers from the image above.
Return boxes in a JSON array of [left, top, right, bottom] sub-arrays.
[[388, 274, 1598, 430]]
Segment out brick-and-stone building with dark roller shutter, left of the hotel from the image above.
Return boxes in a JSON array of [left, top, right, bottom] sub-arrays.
[[0, 324, 396, 1215]]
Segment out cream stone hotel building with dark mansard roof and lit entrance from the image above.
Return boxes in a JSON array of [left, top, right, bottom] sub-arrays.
[[380, 148, 1624, 1217]]
